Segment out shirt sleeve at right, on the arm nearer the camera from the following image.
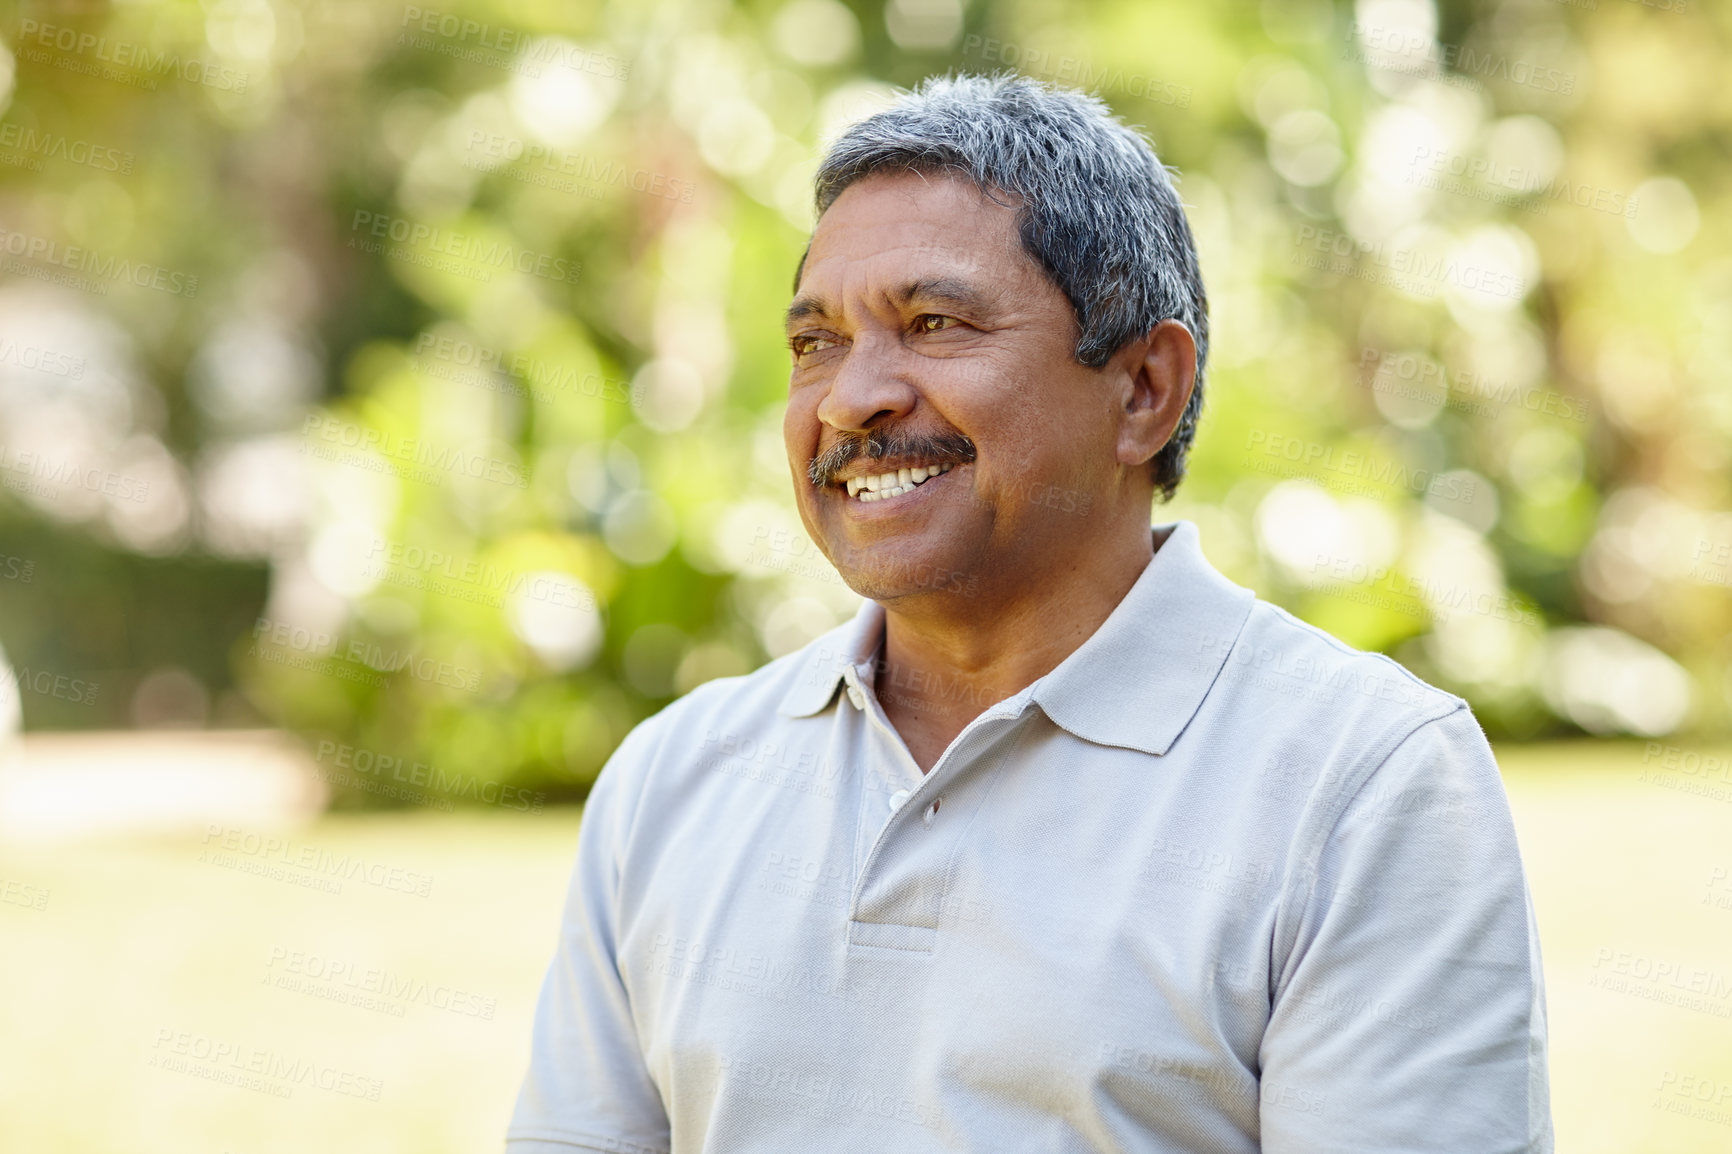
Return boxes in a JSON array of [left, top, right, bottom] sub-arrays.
[[1261, 707, 1552, 1154]]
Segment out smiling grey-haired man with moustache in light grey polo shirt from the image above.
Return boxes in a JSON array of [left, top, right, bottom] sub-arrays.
[[507, 78, 1550, 1154]]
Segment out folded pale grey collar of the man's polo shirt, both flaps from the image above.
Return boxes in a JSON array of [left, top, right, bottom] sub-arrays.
[[781, 522, 1256, 754]]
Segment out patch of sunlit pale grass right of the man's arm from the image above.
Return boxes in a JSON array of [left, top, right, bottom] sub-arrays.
[[1498, 742, 1732, 1154]]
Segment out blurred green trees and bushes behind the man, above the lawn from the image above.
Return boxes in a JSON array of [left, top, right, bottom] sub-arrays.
[[0, 0, 1732, 802]]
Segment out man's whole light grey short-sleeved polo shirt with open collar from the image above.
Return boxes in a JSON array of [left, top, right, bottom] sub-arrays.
[[507, 522, 1552, 1154]]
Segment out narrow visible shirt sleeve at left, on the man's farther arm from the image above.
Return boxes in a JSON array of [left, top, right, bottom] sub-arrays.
[[506, 724, 669, 1154]]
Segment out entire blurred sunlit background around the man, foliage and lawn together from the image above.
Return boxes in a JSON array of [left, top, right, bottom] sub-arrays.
[[0, 0, 1732, 1154]]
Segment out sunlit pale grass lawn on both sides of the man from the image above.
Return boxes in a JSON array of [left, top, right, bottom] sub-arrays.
[[0, 743, 1732, 1154]]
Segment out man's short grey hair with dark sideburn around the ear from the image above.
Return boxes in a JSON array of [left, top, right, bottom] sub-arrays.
[[807, 73, 1209, 499]]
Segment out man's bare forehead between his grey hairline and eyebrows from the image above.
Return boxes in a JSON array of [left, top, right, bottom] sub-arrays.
[[800, 172, 1036, 295]]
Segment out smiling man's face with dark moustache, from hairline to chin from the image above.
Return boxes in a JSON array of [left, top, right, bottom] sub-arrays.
[[783, 173, 1121, 601]]
